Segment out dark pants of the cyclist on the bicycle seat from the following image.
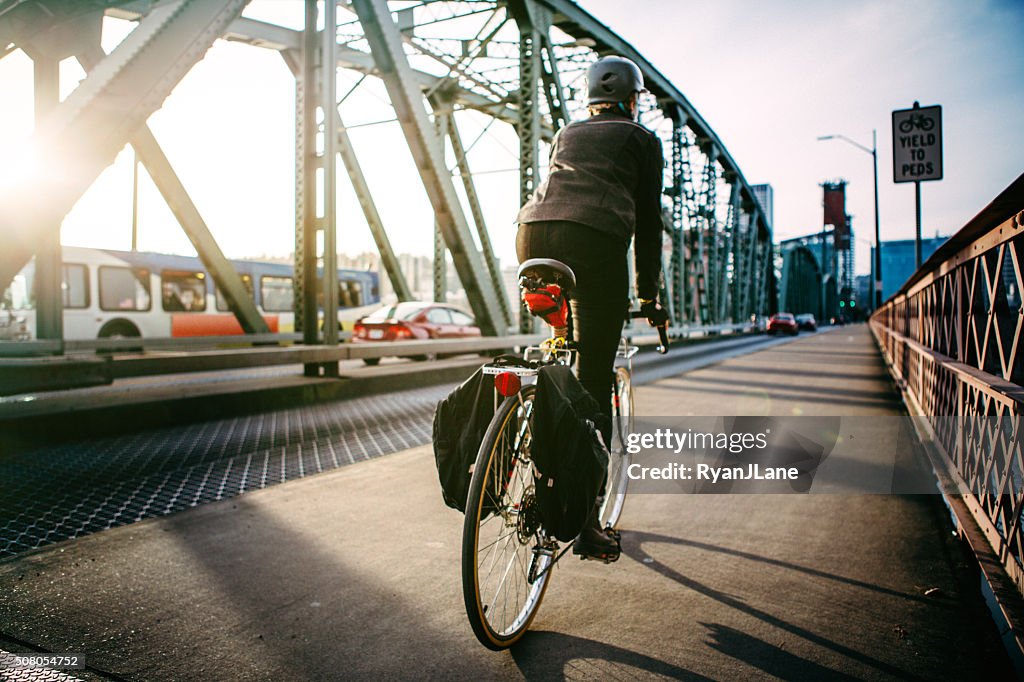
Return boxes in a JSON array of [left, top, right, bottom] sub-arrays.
[[515, 221, 629, 447]]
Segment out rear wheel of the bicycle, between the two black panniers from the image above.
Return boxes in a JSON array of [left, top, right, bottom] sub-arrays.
[[462, 386, 557, 650]]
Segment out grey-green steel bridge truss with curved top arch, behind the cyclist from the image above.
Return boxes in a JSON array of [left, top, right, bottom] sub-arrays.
[[0, 0, 776, 360]]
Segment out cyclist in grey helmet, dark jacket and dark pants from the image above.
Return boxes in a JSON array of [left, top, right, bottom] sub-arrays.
[[516, 56, 668, 556]]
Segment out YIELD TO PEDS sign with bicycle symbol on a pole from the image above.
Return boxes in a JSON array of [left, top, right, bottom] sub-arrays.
[[893, 105, 942, 182]]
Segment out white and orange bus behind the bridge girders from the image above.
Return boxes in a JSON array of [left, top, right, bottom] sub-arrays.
[[0, 247, 380, 340]]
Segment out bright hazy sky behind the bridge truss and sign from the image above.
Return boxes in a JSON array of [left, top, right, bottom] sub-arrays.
[[0, 0, 1024, 272]]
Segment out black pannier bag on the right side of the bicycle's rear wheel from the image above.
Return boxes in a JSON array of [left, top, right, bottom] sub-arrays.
[[530, 365, 608, 542]]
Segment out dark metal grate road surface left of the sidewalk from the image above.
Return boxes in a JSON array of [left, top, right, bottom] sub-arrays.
[[0, 378, 452, 557]]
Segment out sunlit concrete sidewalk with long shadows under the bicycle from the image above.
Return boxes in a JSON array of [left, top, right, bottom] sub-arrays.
[[0, 328, 1012, 680]]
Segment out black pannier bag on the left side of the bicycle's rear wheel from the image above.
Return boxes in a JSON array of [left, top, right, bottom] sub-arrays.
[[433, 370, 495, 512]]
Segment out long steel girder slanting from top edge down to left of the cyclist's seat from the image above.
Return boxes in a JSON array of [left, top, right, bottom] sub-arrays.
[[352, 0, 507, 335]]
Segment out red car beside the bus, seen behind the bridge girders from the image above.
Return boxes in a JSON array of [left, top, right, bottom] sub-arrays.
[[352, 301, 480, 365]]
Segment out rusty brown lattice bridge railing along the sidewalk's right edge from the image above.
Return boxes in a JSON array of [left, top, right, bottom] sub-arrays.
[[870, 175, 1024, 592]]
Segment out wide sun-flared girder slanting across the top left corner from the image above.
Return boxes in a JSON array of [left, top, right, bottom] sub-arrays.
[[0, 0, 247, 296]]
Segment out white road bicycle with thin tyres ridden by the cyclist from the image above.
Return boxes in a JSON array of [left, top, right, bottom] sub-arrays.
[[462, 258, 669, 650]]
